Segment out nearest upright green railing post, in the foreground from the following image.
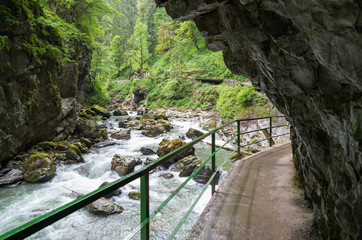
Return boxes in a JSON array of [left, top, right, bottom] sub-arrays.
[[140, 173, 150, 240]]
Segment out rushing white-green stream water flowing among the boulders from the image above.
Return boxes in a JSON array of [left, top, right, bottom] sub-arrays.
[[0, 115, 230, 240]]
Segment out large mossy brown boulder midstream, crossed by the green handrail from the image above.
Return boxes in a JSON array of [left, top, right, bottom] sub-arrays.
[[157, 139, 195, 168]]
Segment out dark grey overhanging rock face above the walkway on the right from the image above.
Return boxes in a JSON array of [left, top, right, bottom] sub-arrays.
[[156, 0, 362, 239]]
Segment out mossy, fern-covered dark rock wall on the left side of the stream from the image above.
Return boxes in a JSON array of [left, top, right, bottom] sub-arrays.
[[0, 0, 92, 166]]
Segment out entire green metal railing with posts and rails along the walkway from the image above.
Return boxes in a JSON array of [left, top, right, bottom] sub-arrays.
[[0, 116, 289, 240]]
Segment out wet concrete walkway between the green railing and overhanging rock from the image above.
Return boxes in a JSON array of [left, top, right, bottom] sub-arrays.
[[188, 142, 312, 240]]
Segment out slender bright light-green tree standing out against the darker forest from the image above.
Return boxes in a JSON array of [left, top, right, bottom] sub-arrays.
[[128, 18, 150, 73]]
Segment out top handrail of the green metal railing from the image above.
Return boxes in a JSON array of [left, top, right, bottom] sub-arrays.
[[0, 116, 284, 240]]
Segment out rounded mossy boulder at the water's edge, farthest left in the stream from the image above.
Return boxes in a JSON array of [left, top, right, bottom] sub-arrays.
[[22, 152, 56, 183]]
